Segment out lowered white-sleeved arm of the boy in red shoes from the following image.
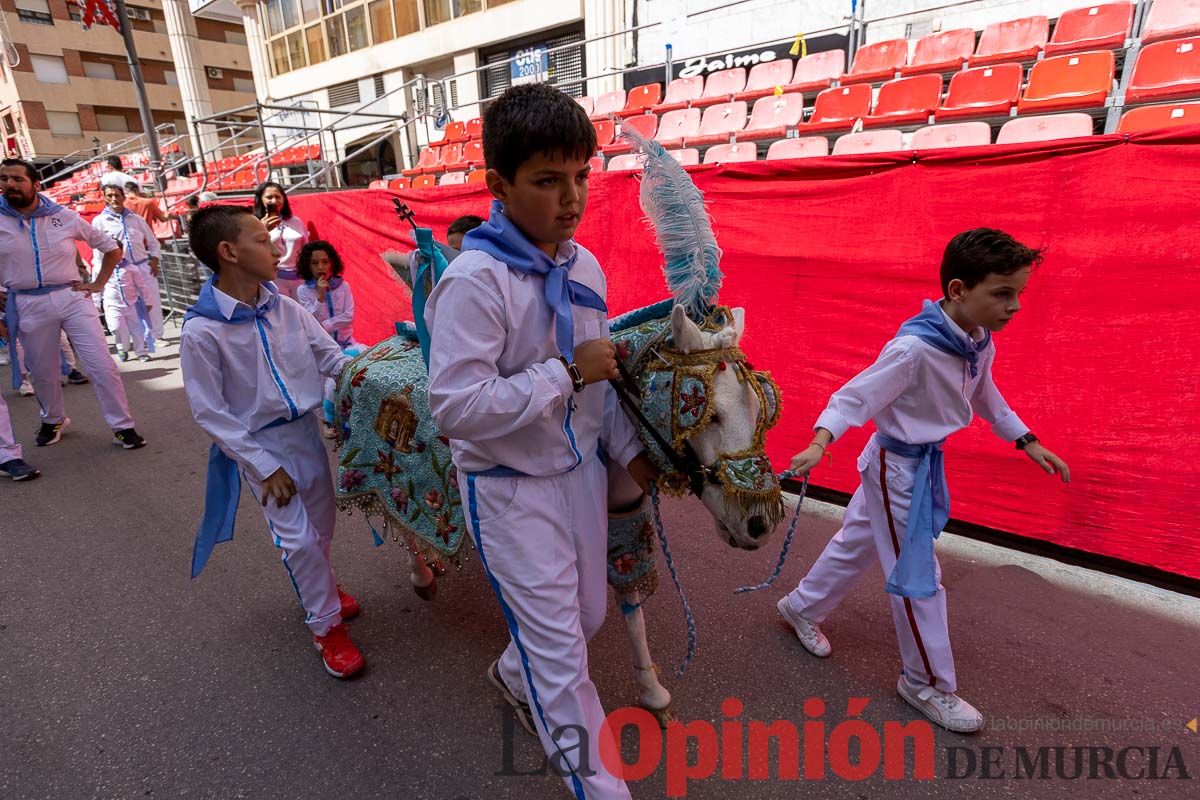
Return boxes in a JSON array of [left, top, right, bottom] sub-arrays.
[[179, 336, 282, 481]]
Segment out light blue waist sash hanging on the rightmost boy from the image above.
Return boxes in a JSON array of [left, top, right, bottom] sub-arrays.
[[875, 433, 950, 597]]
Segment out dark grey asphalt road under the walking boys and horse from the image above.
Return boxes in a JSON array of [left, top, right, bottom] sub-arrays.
[[0, 329, 1200, 800]]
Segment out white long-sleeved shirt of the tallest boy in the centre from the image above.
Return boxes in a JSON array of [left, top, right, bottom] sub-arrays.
[[425, 237, 642, 476]]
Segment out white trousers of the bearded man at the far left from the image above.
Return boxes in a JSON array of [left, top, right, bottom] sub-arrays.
[[17, 289, 133, 431]]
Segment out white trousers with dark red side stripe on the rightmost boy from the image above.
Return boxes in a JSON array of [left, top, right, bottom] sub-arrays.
[[788, 437, 958, 692]]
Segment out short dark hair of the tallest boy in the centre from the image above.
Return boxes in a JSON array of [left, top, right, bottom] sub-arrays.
[[484, 83, 596, 181]]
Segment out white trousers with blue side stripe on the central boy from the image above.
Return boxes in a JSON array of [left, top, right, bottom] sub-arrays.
[[460, 457, 630, 800]]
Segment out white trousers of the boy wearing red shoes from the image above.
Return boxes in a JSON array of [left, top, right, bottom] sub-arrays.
[[242, 414, 342, 636]]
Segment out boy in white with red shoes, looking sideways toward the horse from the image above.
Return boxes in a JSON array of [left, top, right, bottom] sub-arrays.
[[180, 205, 365, 678]]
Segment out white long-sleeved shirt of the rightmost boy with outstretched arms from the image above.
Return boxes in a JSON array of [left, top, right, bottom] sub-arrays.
[[814, 303, 1030, 445]]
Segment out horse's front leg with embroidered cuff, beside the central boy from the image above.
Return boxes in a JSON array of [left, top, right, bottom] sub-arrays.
[[608, 455, 676, 727]]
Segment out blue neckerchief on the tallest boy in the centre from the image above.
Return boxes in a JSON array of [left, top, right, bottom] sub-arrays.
[[462, 200, 608, 361]]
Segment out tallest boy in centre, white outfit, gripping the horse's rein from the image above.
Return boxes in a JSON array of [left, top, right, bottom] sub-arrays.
[[425, 84, 654, 800]]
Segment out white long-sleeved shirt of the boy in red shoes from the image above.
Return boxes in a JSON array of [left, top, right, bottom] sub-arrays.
[[179, 288, 349, 480]]
